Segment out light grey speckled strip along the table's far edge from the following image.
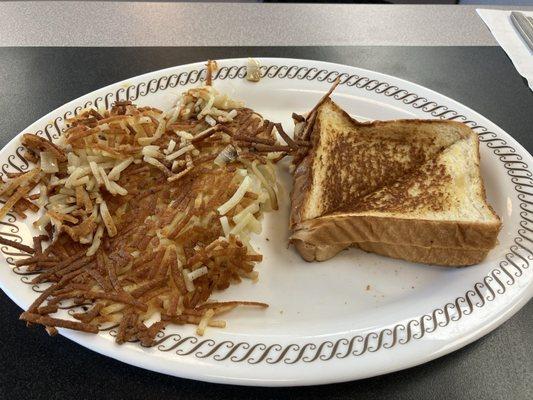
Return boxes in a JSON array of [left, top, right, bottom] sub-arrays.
[[0, 1, 533, 46]]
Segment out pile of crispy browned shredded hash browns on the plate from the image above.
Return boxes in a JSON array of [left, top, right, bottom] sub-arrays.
[[0, 59, 304, 345]]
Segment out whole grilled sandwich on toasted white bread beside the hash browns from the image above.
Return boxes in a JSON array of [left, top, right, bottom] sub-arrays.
[[290, 98, 501, 266]]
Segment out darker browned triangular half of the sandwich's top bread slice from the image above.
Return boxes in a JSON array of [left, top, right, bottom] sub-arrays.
[[293, 99, 469, 222]]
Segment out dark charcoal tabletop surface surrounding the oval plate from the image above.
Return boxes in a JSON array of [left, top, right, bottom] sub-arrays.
[[0, 47, 533, 400]]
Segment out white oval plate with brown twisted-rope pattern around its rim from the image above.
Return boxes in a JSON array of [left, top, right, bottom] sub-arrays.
[[0, 58, 533, 386]]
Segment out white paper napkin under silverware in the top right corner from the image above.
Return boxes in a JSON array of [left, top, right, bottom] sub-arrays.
[[476, 9, 533, 90]]
